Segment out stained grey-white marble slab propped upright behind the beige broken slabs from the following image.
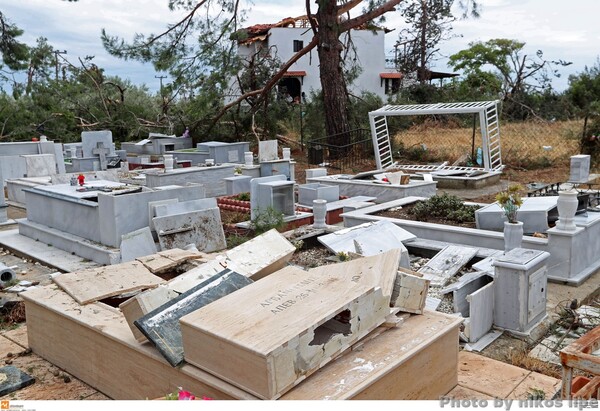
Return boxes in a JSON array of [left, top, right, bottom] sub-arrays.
[[152, 208, 227, 253]]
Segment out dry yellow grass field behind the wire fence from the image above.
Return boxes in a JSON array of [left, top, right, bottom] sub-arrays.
[[393, 121, 583, 169]]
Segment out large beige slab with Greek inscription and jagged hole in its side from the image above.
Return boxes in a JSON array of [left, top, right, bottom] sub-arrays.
[[180, 250, 400, 399]]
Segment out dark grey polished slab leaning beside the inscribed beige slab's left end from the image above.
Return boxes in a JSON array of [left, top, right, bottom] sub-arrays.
[[134, 269, 253, 367]]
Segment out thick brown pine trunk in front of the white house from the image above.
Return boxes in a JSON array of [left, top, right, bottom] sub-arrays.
[[316, 0, 350, 156]]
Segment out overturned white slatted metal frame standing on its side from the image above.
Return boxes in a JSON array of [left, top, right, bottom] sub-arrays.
[[369, 100, 503, 171]]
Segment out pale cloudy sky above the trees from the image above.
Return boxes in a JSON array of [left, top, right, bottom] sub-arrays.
[[0, 0, 600, 92]]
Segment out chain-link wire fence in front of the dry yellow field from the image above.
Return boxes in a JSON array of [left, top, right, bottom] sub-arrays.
[[390, 119, 583, 169]]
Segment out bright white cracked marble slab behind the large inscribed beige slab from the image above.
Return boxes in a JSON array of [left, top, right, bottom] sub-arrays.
[[318, 221, 416, 268]]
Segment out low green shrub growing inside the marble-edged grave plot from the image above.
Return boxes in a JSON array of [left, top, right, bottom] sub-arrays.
[[408, 193, 479, 223]]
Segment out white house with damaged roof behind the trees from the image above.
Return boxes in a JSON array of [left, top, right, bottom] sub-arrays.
[[230, 16, 402, 101]]
